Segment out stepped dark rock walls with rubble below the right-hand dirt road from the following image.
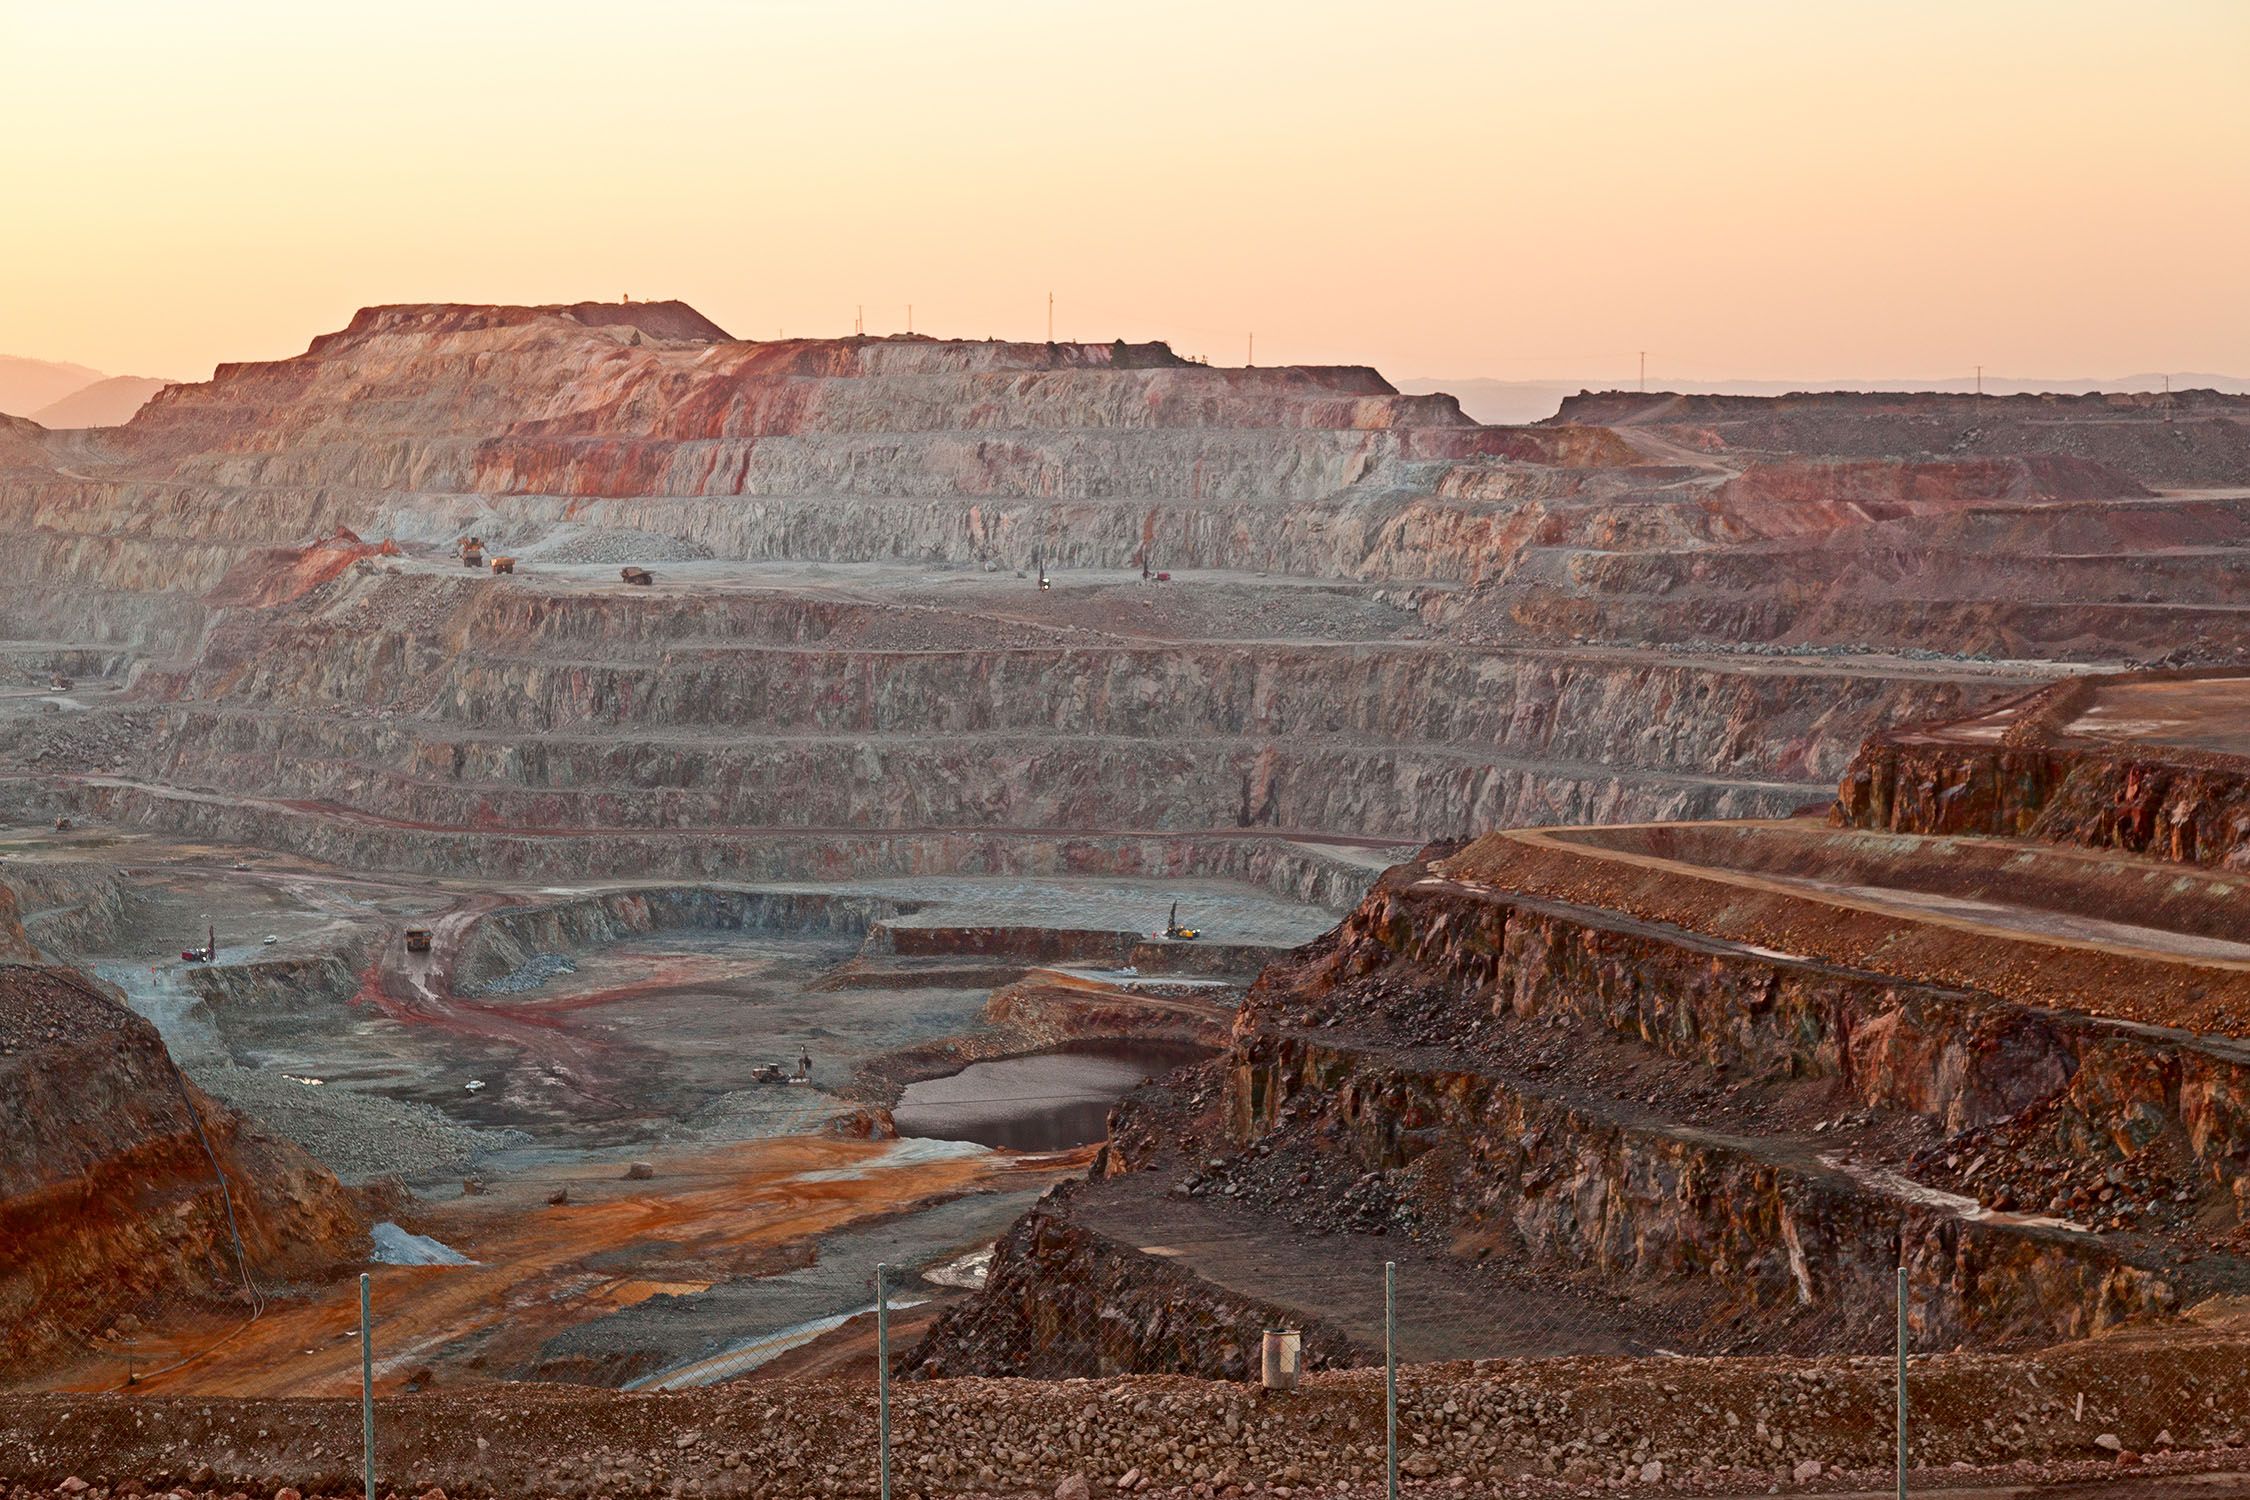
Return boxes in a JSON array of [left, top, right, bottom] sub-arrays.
[[916, 827, 2250, 1376]]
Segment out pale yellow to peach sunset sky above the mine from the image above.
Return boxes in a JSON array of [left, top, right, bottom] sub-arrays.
[[0, 0, 2250, 385]]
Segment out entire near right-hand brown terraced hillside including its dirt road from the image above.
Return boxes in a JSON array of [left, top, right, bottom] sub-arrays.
[[916, 706, 2250, 1376]]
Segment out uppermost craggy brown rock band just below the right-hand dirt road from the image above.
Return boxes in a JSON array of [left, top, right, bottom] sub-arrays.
[[1314, 879, 2250, 1212]]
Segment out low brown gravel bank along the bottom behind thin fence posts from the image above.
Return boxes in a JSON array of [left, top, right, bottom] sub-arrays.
[[0, 1345, 2250, 1500]]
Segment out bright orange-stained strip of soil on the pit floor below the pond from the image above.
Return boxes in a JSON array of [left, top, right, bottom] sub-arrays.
[[36, 1138, 1085, 1397]]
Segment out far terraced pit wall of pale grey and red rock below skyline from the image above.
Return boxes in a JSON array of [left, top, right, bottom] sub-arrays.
[[0, 304, 2250, 881]]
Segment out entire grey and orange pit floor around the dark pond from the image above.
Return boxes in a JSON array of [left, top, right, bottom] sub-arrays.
[[0, 830, 1332, 1394]]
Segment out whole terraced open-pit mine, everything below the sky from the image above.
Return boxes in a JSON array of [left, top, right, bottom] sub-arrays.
[[0, 301, 2250, 1496]]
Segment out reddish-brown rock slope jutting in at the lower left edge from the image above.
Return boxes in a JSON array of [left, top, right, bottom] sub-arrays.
[[0, 963, 367, 1370]]
